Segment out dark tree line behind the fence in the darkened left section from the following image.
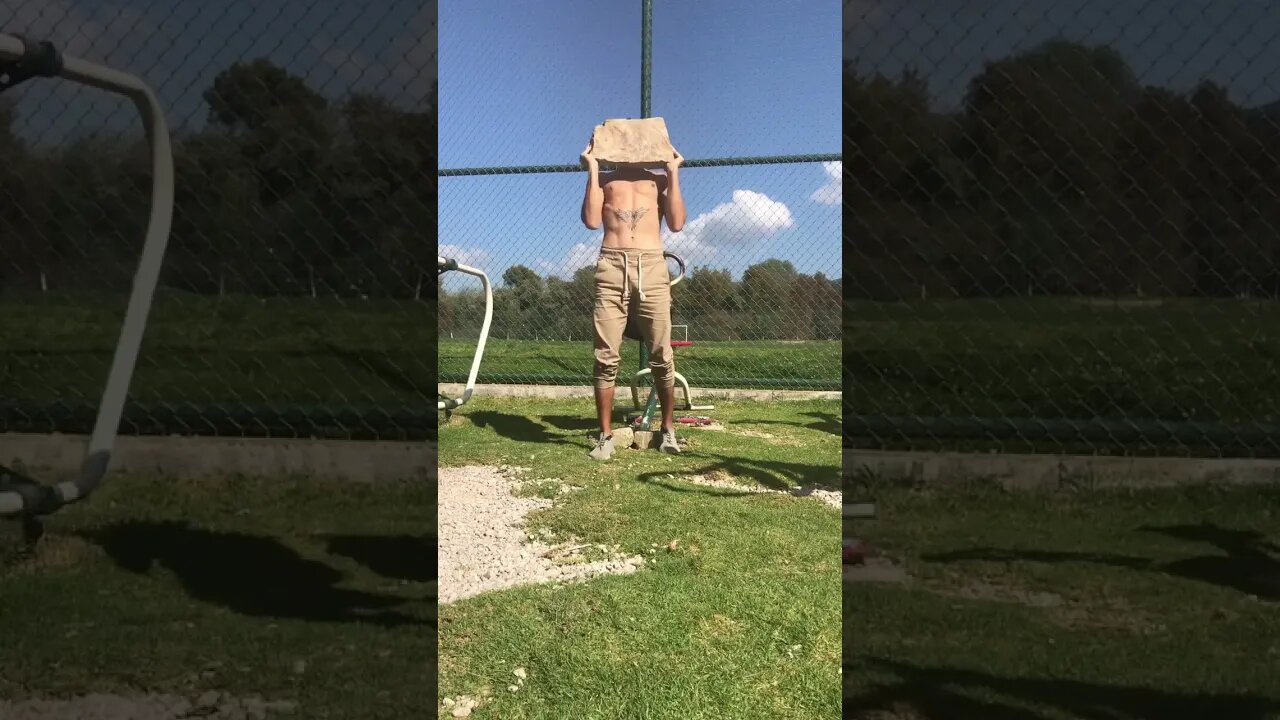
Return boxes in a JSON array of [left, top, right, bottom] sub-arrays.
[[0, 60, 436, 299]]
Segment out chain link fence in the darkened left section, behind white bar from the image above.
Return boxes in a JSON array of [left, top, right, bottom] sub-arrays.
[[0, 0, 436, 439]]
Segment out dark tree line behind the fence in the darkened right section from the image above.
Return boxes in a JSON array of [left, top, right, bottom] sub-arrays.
[[844, 41, 1280, 300]]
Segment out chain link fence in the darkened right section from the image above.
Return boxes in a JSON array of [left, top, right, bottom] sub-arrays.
[[844, 0, 1280, 456]]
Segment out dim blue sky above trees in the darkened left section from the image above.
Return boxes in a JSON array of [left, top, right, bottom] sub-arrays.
[[0, 0, 436, 140]]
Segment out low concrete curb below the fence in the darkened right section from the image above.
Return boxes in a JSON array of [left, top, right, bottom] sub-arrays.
[[842, 450, 1280, 489]]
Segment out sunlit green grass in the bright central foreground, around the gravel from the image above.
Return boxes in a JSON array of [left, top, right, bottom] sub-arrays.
[[439, 397, 840, 720]]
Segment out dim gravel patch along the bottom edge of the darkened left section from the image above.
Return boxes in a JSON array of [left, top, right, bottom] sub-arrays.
[[0, 691, 297, 720]]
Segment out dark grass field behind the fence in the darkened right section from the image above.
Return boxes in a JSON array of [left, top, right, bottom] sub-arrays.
[[844, 299, 1280, 424]]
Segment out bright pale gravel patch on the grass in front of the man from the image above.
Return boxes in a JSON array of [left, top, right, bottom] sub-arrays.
[[438, 465, 645, 605]]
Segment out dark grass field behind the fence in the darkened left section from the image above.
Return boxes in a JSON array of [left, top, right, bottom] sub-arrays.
[[0, 288, 435, 410]]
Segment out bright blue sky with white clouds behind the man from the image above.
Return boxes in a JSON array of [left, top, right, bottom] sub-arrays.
[[439, 0, 841, 285]]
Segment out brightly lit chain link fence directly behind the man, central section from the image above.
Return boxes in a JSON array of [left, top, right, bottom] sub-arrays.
[[438, 0, 844, 389]]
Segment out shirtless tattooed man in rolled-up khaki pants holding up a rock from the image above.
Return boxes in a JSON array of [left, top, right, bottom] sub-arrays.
[[582, 144, 685, 460]]
